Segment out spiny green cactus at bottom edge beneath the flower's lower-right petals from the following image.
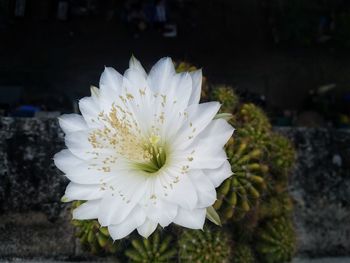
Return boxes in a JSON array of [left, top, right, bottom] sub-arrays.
[[179, 228, 231, 263]]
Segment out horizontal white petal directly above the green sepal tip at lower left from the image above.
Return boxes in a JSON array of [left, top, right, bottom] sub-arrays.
[[65, 182, 104, 200]]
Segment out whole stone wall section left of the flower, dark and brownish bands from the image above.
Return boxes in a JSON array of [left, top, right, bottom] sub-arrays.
[[0, 118, 76, 257]]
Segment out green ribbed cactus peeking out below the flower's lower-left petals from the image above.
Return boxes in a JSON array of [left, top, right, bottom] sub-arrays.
[[72, 201, 119, 255]]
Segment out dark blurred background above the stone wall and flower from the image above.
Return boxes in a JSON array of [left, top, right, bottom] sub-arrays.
[[0, 0, 350, 127]]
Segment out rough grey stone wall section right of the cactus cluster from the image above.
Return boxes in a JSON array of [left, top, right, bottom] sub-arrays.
[[278, 128, 350, 256]]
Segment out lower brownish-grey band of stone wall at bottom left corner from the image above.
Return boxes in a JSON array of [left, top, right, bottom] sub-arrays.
[[0, 209, 75, 257]]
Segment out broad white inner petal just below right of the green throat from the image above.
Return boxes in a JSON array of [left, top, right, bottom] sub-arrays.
[[163, 172, 198, 209]]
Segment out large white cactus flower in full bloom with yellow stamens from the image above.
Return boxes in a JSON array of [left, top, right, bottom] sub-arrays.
[[54, 58, 233, 239]]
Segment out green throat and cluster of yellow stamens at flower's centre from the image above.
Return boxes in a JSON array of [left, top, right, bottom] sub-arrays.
[[89, 104, 167, 174]]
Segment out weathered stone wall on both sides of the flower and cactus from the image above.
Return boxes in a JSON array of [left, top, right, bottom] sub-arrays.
[[0, 118, 350, 258]]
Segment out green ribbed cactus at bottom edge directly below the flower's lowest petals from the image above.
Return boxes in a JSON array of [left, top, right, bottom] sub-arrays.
[[125, 230, 177, 263]]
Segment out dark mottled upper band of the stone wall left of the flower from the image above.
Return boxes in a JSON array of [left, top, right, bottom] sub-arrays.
[[0, 118, 67, 218]]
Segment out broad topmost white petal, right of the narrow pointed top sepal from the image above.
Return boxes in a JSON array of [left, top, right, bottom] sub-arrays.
[[147, 58, 176, 94]]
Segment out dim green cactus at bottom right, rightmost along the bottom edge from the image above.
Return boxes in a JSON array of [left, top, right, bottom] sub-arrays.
[[255, 217, 296, 263]]
